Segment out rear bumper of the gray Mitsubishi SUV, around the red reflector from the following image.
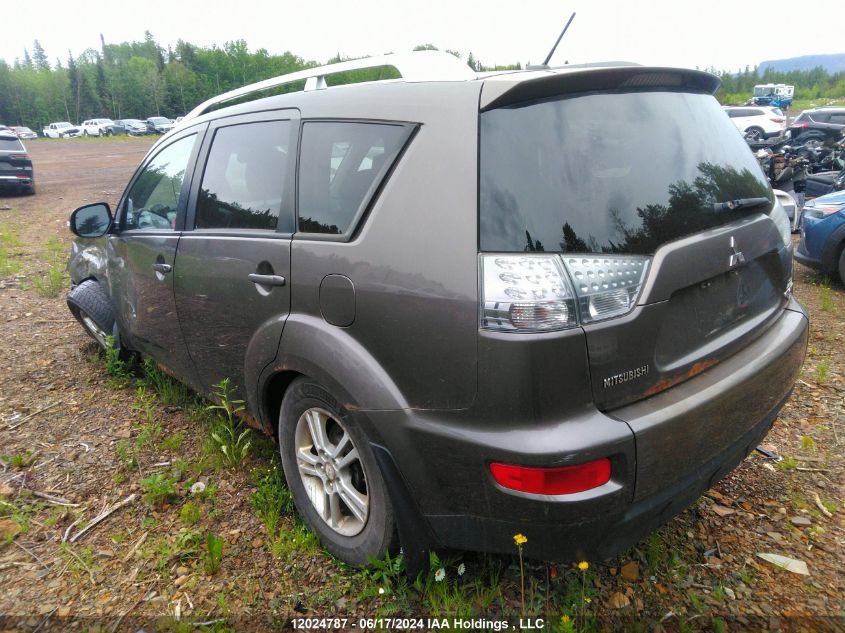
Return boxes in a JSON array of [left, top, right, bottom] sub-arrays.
[[366, 300, 808, 561]]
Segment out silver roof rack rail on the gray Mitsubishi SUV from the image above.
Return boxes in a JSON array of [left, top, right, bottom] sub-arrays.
[[182, 51, 476, 121]]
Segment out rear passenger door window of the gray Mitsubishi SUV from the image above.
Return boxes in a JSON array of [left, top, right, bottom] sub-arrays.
[[196, 121, 291, 230]]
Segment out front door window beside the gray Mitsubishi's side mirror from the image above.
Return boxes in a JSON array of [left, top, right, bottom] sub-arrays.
[[121, 134, 196, 231]]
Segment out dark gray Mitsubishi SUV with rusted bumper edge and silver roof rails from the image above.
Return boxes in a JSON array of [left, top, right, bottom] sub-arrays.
[[68, 52, 808, 565]]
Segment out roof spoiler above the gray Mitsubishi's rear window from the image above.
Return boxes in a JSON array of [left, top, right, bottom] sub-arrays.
[[479, 65, 722, 112]]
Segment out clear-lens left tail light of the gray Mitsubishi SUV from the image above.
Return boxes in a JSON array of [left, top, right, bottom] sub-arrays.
[[480, 254, 649, 332]]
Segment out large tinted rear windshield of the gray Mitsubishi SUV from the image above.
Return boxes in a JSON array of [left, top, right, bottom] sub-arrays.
[[479, 92, 772, 254]]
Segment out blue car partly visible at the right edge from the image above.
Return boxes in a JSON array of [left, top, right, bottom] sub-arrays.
[[795, 191, 845, 284]]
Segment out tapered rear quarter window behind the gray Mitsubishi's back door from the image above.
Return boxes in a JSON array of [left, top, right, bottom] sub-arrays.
[[298, 121, 411, 235]]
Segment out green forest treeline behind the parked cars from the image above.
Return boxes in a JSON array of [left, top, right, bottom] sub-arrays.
[[0, 31, 845, 130]]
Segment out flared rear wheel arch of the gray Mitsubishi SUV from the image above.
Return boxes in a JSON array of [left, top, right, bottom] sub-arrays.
[[251, 314, 409, 420]]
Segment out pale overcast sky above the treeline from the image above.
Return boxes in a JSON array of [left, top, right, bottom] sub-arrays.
[[6, 0, 845, 71]]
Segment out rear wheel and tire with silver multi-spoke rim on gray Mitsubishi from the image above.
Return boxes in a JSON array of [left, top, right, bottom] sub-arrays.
[[279, 377, 397, 567]]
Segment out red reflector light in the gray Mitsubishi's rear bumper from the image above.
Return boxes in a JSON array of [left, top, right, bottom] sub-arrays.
[[490, 457, 610, 495]]
